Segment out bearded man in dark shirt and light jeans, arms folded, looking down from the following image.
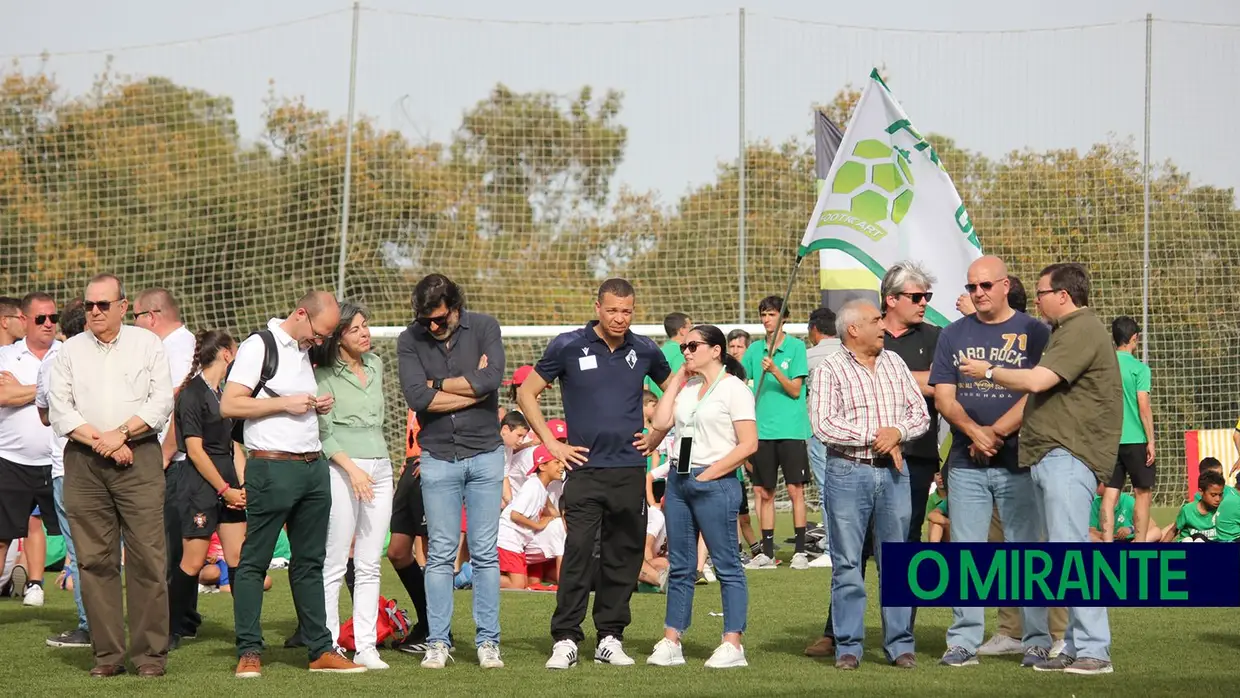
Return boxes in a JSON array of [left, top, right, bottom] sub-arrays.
[[397, 274, 505, 669]]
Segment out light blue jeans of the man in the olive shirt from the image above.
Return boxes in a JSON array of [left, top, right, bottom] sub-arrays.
[[1026, 449, 1111, 662]]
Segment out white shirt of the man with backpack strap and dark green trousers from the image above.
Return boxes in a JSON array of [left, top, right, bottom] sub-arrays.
[[228, 317, 322, 454]]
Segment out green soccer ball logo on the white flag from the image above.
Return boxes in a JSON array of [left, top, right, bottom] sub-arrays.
[[831, 139, 914, 241]]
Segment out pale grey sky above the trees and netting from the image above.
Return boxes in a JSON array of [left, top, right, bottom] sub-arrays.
[[0, 0, 1240, 203]]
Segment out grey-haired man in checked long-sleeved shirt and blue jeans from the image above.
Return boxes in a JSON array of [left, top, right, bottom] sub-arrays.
[[810, 300, 930, 669]]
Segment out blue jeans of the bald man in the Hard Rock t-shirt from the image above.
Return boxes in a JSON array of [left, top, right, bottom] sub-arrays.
[[947, 461, 1050, 653]]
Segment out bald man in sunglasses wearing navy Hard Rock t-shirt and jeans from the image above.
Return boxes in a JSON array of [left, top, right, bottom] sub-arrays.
[[930, 255, 1050, 667]]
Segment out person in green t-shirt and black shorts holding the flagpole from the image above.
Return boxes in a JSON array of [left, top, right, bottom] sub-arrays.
[[740, 296, 810, 569]]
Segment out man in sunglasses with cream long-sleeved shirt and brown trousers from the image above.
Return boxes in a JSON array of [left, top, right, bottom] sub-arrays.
[[48, 274, 172, 678]]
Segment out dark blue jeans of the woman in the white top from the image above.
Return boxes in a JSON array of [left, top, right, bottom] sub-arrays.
[[663, 469, 749, 635]]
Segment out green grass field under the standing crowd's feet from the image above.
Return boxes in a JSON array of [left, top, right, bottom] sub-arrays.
[[0, 510, 1240, 698]]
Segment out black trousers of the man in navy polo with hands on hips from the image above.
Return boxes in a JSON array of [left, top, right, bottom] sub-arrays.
[[551, 466, 646, 642]]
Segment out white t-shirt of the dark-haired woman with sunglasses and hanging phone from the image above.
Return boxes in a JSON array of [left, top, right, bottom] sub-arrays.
[[672, 373, 755, 466]]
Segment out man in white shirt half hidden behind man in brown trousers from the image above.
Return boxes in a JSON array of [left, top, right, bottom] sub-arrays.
[[134, 288, 202, 640]]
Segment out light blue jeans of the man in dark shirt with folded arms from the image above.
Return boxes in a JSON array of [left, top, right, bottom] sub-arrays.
[[422, 448, 503, 646]]
